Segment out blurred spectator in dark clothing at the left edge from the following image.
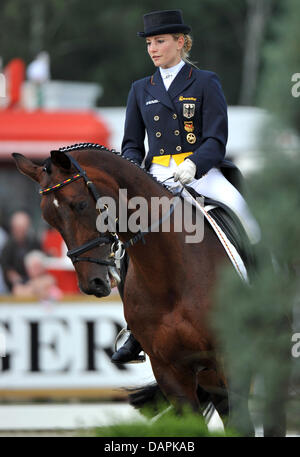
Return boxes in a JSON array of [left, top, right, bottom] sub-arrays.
[[1, 211, 40, 291]]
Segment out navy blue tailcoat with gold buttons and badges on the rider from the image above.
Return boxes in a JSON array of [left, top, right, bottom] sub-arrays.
[[122, 63, 240, 181]]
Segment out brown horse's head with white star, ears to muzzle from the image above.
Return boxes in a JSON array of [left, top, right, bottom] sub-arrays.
[[13, 150, 116, 297]]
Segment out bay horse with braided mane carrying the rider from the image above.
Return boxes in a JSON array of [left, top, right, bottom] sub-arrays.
[[13, 144, 270, 436]]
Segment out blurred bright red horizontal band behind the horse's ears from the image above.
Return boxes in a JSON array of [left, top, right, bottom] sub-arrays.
[[0, 109, 110, 159]]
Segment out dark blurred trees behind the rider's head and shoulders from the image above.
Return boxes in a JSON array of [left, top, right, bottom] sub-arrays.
[[0, 0, 287, 106]]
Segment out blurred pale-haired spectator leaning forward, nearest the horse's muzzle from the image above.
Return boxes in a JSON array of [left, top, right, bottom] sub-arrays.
[[12, 250, 63, 301]]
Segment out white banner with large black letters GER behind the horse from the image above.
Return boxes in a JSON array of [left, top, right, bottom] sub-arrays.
[[0, 301, 154, 395]]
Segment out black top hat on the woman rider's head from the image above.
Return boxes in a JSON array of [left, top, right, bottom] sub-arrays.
[[138, 10, 191, 38]]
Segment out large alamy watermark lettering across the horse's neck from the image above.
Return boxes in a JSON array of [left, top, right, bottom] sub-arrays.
[[96, 189, 204, 243]]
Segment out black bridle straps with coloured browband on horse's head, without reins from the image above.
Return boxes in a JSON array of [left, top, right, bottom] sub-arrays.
[[39, 154, 119, 267]]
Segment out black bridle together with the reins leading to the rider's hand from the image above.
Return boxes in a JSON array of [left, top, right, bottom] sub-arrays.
[[39, 153, 177, 266]]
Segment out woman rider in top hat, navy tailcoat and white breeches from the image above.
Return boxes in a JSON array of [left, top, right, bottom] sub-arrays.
[[112, 10, 260, 363]]
